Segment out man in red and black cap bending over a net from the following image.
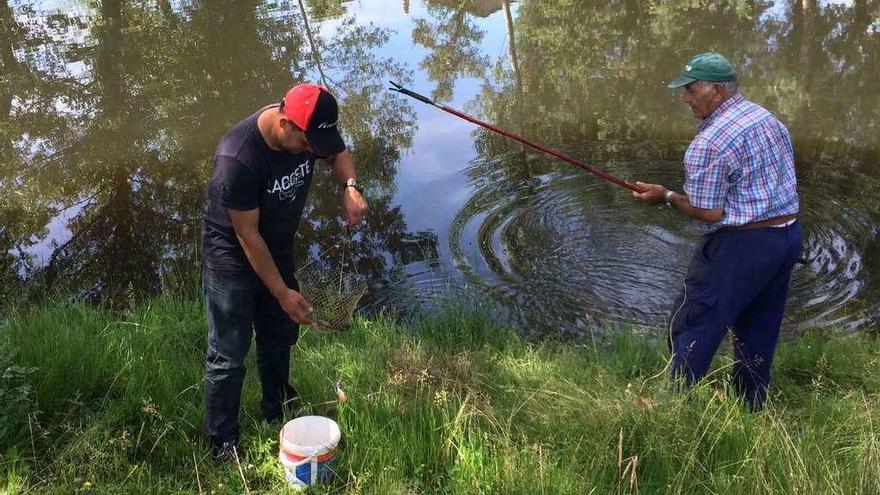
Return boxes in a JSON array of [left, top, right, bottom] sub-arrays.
[[202, 84, 367, 459]]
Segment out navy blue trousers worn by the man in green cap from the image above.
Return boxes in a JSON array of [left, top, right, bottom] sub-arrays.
[[669, 221, 803, 410]]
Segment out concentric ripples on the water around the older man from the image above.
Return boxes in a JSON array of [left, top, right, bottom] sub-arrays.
[[449, 148, 880, 334]]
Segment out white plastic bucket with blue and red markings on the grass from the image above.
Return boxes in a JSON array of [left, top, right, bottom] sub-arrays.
[[278, 416, 342, 489]]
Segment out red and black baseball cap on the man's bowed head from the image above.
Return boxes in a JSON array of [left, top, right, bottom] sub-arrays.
[[284, 83, 345, 156]]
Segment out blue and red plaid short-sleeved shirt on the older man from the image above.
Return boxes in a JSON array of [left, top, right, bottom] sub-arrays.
[[684, 94, 798, 230]]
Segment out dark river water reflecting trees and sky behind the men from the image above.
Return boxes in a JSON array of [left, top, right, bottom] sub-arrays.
[[0, 0, 880, 335]]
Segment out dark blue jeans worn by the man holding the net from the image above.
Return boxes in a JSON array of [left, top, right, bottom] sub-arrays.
[[202, 266, 299, 445]]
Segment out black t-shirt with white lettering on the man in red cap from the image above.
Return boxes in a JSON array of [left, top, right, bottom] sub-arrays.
[[202, 107, 316, 271]]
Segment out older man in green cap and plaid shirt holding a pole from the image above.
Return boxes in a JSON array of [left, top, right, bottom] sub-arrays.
[[633, 52, 803, 410]]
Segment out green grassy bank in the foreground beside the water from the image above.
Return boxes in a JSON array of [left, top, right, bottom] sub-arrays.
[[0, 299, 880, 494]]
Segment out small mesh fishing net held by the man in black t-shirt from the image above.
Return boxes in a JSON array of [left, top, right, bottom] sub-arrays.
[[296, 237, 367, 333]]
